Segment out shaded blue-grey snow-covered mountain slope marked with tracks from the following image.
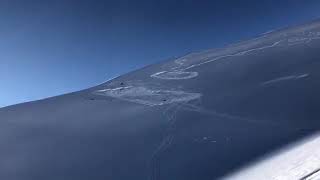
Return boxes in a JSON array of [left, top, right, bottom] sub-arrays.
[[0, 21, 320, 180]]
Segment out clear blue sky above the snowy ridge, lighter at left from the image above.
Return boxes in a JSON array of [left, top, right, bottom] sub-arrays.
[[0, 0, 320, 107]]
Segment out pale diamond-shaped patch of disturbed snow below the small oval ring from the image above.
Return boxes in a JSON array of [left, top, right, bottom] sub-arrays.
[[95, 86, 201, 106]]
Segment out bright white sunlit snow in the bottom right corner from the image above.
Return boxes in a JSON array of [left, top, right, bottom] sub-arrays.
[[222, 134, 320, 180]]
